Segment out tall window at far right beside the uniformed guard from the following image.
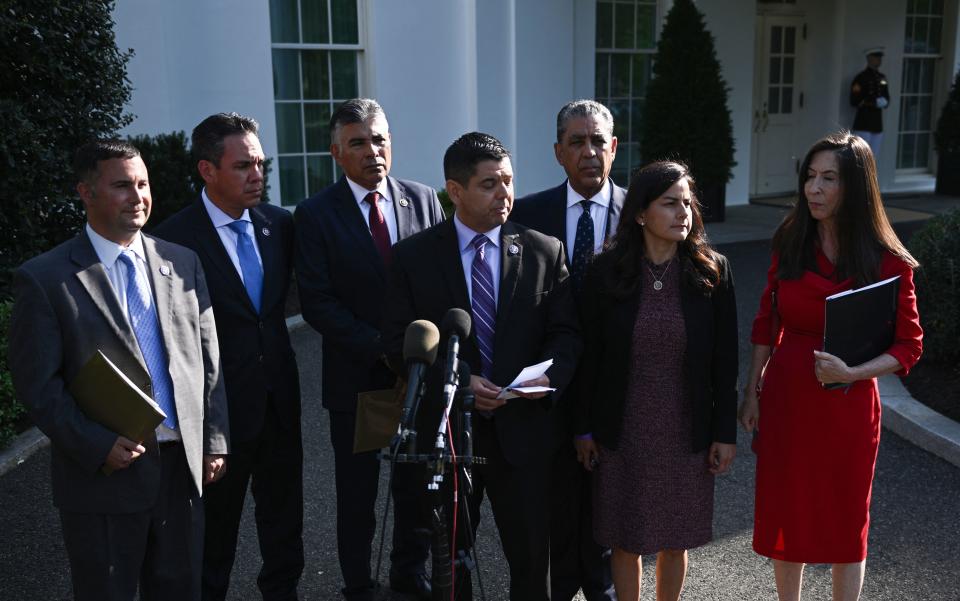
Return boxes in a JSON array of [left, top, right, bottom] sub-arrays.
[[897, 0, 943, 172]]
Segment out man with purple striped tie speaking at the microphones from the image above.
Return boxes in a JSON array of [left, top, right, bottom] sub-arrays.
[[384, 133, 581, 601]]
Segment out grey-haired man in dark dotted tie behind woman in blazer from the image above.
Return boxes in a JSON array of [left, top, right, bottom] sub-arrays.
[[510, 100, 627, 601]]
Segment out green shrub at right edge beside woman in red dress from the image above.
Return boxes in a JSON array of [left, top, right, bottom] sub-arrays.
[[910, 209, 960, 363]]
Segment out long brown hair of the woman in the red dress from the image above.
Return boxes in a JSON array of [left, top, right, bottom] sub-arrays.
[[773, 131, 918, 287]]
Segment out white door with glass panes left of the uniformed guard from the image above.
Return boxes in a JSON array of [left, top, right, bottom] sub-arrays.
[[751, 15, 804, 196]]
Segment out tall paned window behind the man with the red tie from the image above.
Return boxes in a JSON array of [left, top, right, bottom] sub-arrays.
[[270, 0, 361, 205]]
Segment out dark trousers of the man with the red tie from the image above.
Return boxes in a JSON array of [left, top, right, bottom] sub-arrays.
[[330, 411, 430, 599]]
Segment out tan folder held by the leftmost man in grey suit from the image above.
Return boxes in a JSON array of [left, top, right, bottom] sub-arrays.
[[70, 350, 167, 443]]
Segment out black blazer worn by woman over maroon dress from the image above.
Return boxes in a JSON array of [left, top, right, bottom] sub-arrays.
[[577, 248, 739, 452]]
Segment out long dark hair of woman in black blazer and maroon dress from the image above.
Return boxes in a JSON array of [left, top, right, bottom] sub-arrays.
[[603, 161, 720, 298]]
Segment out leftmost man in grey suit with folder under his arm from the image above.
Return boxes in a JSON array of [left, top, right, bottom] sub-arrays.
[[9, 140, 229, 601]]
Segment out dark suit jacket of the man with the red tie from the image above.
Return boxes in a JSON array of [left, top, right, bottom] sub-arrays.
[[295, 177, 444, 411]]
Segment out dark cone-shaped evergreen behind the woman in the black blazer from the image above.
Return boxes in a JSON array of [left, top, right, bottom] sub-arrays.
[[640, 0, 736, 187]]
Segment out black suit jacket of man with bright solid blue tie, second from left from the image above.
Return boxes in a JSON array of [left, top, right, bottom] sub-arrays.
[[154, 198, 300, 442]]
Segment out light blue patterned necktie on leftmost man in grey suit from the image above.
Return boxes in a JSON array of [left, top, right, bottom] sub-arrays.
[[119, 250, 177, 429]]
